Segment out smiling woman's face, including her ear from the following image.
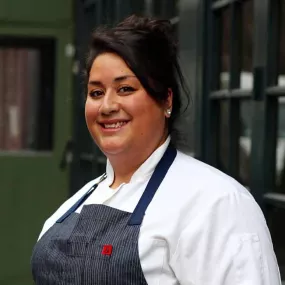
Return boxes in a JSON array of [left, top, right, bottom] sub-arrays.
[[85, 53, 172, 156]]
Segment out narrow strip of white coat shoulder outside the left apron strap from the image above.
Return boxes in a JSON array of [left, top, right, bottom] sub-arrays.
[[39, 176, 101, 238]]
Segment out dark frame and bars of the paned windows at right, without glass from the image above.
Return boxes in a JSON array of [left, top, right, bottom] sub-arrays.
[[196, 0, 285, 211]]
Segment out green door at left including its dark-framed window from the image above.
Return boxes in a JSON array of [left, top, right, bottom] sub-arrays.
[[0, 0, 73, 285]]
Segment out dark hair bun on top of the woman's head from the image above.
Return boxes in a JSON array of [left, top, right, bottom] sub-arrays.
[[117, 15, 177, 54]]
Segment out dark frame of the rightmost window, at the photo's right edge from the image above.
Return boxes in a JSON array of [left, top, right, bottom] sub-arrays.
[[262, 0, 285, 210]]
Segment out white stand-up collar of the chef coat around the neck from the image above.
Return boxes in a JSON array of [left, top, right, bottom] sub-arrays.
[[106, 136, 170, 187]]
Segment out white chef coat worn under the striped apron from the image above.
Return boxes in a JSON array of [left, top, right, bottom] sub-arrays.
[[40, 138, 281, 285]]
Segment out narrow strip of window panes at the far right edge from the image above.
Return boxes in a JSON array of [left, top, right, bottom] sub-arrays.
[[266, 0, 285, 194]]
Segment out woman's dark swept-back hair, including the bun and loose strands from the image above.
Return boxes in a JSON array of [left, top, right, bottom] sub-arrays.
[[85, 15, 189, 145]]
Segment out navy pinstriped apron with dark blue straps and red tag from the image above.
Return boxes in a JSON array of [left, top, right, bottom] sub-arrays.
[[32, 146, 177, 285]]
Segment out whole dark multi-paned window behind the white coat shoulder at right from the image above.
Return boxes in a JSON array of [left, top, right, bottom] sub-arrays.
[[198, 0, 285, 280]]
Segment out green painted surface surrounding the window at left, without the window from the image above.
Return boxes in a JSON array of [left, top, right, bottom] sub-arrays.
[[0, 0, 73, 285]]
